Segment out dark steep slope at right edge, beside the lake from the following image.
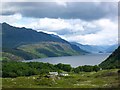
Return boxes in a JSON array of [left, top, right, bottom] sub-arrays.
[[99, 46, 120, 69]]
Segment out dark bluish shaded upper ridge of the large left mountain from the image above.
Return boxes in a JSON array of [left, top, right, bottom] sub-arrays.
[[2, 23, 68, 48]]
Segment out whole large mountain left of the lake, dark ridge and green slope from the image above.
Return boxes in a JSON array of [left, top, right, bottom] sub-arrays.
[[0, 23, 87, 59]]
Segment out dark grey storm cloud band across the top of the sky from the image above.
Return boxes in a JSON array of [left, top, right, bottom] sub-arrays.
[[2, 2, 117, 20]]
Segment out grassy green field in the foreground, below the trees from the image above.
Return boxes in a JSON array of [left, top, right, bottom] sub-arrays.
[[1, 69, 120, 88]]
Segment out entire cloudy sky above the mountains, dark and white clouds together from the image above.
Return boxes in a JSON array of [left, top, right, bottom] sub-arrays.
[[0, 0, 118, 45]]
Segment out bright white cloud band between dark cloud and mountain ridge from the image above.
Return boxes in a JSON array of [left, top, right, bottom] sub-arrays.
[[0, 14, 118, 45]]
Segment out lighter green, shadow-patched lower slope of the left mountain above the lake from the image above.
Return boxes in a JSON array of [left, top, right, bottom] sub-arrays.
[[17, 42, 79, 58]]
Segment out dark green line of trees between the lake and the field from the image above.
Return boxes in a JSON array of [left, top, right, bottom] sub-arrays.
[[2, 61, 100, 77]]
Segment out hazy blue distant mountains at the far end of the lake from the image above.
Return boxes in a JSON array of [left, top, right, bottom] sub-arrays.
[[71, 42, 117, 53]]
